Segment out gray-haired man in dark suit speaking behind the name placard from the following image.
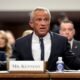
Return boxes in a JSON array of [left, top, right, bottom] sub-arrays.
[[13, 7, 80, 71]]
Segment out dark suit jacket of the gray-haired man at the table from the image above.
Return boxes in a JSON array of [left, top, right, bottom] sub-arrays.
[[13, 33, 80, 71]]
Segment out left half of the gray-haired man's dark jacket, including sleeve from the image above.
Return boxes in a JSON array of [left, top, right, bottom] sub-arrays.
[[13, 34, 33, 60]]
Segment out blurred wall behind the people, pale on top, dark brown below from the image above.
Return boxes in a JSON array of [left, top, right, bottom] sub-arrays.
[[0, 0, 80, 40]]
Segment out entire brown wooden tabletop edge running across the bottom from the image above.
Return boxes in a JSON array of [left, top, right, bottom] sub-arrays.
[[0, 72, 80, 80]]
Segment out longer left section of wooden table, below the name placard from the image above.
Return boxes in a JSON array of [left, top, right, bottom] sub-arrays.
[[0, 72, 49, 80]]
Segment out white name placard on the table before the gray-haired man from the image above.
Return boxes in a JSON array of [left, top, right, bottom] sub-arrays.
[[9, 61, 44, 72]]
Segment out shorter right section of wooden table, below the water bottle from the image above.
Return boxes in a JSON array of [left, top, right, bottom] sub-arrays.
[[50, 72, 80, 80]]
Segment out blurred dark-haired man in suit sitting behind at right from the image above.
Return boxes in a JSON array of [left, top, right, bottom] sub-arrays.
[[60, 20, 80, 57]]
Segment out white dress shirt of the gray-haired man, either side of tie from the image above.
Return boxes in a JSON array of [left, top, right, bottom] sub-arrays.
[[32, 33, 51, 61]]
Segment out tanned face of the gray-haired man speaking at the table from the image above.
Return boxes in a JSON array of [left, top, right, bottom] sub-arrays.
[[31, 11, 50, 37]]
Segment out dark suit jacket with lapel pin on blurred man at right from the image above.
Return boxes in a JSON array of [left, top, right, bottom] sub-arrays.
[[72, 40, 80, 57]]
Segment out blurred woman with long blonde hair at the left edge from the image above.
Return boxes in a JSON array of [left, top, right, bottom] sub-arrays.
[[0, 30, 12, 70]]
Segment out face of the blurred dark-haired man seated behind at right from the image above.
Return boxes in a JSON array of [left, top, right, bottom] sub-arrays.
[[60, 23, 75, 41]]
